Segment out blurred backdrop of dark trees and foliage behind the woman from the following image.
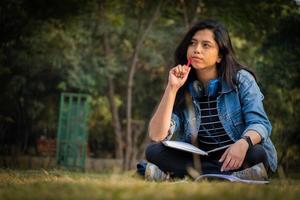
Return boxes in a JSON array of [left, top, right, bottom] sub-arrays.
[[0, 0, 300, 173]]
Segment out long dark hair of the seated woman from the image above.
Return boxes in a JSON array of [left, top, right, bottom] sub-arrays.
[[175, 19, 255, 106]]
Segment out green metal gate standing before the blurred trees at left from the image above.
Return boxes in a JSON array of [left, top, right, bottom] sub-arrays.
[[56, 93, 89, 170]]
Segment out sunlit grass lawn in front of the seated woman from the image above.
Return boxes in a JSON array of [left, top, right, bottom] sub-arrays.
[[0, 169, 300, 200]]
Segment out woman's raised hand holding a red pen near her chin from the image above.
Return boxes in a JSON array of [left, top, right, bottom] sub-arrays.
[[168, 65, 191, 90]]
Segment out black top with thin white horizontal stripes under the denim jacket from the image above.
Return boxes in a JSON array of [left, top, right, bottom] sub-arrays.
[[198, 96, 233, 151]]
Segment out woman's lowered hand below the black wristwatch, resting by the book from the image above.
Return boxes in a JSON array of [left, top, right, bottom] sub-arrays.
[[219, 139, 249, 172]]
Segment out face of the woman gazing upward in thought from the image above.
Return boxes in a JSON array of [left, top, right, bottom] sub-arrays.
[[187, 29, 221, 70]]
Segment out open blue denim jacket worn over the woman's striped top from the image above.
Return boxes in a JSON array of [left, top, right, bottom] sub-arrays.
[[166, 70, 277, 171]]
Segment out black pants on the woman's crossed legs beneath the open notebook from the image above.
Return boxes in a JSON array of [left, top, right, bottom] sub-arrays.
[[146, 142, 269, 177]]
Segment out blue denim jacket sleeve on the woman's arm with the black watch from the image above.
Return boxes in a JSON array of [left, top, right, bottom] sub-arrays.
[[238, 70, 272, 142]]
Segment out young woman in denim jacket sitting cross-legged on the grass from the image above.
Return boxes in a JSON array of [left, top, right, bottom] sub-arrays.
[[146, 20, 277, 180]]
